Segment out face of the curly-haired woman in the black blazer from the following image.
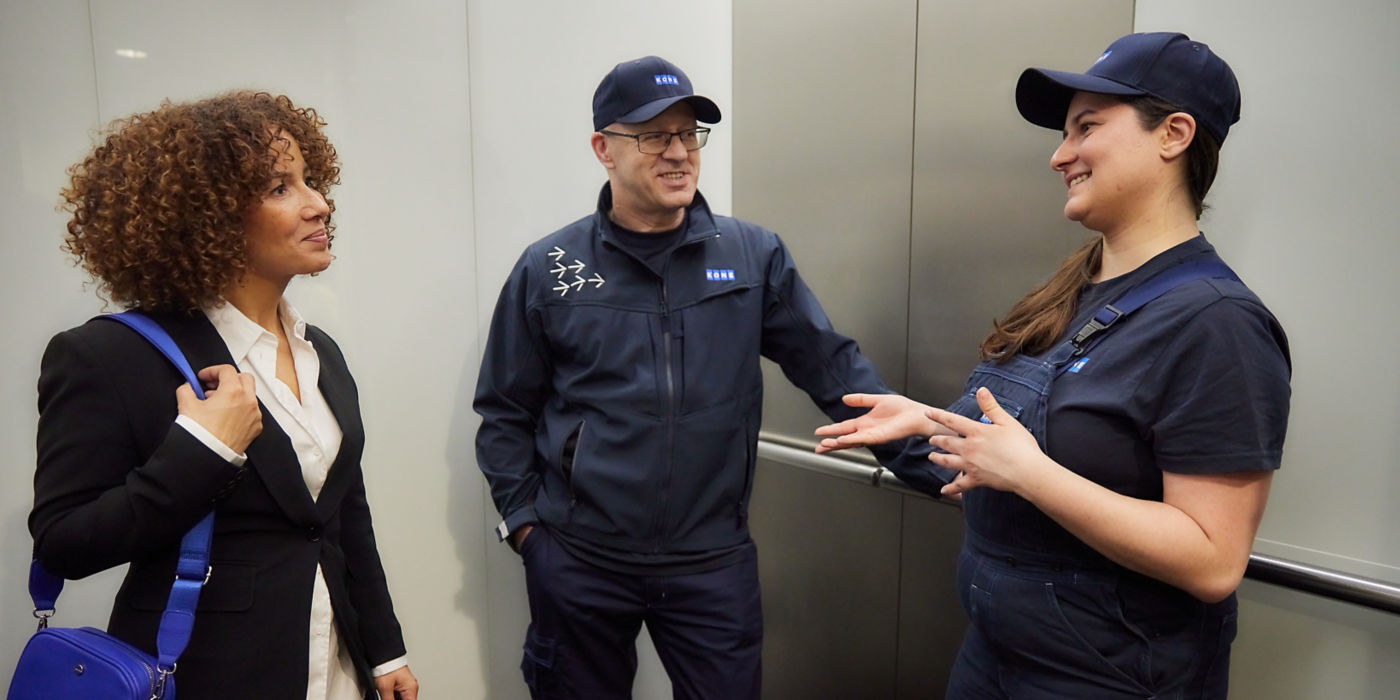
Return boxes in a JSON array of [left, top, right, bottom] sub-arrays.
[[244, 132, 332, 287]]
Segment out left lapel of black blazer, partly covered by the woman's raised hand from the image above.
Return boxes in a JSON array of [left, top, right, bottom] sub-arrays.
[[150, 312, 316, 522]]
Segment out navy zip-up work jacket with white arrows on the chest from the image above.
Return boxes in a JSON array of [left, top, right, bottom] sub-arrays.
[[475, 185, 930, 554]]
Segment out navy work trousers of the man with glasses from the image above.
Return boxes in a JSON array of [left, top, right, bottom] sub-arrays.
[[521, 525, 763, 700]]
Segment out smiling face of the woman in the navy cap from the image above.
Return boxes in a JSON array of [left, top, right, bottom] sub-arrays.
[[1050, 92, 1166, 232]]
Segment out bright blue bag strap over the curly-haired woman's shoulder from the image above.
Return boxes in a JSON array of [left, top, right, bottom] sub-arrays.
[[29, 311, 214, 673]]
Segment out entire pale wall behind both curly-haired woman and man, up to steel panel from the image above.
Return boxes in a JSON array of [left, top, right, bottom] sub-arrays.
[[0, 0, 732, 699]]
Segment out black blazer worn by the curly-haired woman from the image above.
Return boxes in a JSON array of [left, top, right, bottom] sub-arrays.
[[29, 312, 405, 700]]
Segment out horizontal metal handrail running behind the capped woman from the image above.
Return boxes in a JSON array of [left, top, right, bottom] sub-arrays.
[[759, 431, 1400, 615]]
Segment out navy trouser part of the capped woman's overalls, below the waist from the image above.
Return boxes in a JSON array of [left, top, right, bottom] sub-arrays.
[[946, 532, 1236, 700]]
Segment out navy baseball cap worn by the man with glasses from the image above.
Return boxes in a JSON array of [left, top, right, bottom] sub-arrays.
[[594, 56, 720, 132]]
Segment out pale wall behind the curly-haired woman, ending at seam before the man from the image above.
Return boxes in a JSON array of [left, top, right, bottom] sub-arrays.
[[0, 0, 486, 697]]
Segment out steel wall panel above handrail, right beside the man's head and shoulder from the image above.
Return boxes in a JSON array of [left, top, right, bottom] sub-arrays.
[[734, 0, 917, 437]]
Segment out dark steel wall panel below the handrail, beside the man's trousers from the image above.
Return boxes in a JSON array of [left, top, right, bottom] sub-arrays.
[[749, 462, 904, 699]]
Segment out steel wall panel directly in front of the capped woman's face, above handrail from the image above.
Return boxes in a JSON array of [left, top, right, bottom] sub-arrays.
[[909, 0, 1133, 405]]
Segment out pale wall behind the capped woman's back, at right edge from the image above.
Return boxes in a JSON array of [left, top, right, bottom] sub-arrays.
[[1135, 0, 1400, 700]]
